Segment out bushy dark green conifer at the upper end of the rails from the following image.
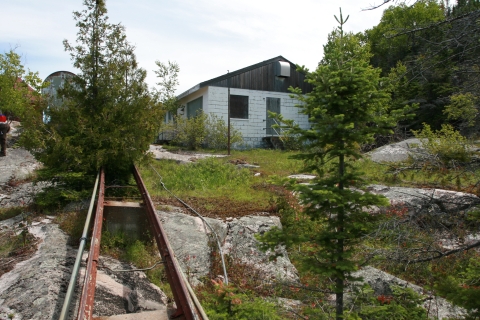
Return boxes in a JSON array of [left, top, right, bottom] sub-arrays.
[[36, 0, 164, 177]]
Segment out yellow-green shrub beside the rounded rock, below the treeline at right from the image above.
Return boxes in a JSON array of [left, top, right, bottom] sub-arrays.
[[413, 123, 472, 166]]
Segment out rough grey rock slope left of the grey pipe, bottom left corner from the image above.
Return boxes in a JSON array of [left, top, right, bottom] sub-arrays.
[[0, 220, 76, 320]]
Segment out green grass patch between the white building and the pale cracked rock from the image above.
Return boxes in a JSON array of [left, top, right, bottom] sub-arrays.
[[141, 150, 303, 218]]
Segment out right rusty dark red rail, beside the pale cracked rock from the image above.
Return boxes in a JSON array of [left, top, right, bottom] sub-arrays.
[[133, 166, 203, 320]]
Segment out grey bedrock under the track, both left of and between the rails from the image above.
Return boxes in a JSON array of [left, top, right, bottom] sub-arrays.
[[0, 219, 167, 320]]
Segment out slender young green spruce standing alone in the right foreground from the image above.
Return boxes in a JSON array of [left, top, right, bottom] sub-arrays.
[[263, 12, 395, 319]]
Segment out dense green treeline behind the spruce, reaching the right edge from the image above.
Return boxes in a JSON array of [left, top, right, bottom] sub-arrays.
[[363, 0, 480, 137]]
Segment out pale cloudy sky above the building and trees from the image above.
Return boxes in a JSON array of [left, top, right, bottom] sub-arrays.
[[0, 0, 385, 94]]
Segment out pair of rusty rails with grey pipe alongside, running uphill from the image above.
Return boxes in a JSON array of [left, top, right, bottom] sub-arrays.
[[60, 166, 208, 320]]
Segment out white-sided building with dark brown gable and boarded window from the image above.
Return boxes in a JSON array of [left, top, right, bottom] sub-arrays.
[[166, 56, 311, 148]]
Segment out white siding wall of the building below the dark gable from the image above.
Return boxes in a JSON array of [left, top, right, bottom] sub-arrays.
[[180, 86, 309, 148]]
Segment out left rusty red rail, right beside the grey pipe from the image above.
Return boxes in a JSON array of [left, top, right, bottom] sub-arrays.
[[77, 168, 105, 320]]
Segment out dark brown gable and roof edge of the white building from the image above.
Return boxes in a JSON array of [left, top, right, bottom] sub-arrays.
[[177, 56, 310, 99]]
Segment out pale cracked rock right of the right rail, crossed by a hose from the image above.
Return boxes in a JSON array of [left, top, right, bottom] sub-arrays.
[[157, 210, 298, 285]]
